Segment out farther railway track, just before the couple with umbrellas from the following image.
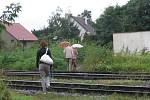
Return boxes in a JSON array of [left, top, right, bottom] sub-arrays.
[[4, 71, 150, 80]]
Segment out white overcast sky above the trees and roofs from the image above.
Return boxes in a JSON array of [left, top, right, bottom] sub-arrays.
[[0, 0, 129, 31]]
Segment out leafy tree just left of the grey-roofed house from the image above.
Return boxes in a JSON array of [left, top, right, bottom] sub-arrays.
[[48, 13, 79, 39]]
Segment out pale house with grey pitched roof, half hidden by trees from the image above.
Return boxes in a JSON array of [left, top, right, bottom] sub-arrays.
[[65, 14, 96, 41]]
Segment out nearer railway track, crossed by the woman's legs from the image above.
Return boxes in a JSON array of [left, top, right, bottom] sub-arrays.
[[5, 80, 150, 95]]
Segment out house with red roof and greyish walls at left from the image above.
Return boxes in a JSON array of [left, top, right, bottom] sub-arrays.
[[0, 23, 38, 48]]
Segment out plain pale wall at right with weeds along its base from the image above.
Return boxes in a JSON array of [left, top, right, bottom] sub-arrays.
[[113, 31, 150, 53]]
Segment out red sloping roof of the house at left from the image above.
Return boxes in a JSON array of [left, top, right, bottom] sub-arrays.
[[5, 23, 38, 41]]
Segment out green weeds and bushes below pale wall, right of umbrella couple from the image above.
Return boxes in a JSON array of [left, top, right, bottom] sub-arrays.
[[81, 45, 150, 72]]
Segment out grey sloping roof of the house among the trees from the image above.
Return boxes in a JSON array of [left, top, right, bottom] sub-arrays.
[[71, 16, 96, 35]]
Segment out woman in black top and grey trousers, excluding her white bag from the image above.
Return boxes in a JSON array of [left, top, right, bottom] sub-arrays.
[[36, 40, 52, 94]]
